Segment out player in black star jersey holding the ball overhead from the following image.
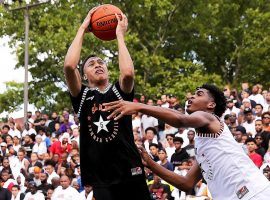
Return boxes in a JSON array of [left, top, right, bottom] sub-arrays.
[[64, 8, 150, 200]]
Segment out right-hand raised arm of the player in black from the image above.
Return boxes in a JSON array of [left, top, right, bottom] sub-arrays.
[[116, 13, 134, 93]]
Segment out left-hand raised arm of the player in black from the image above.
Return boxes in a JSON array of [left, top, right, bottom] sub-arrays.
[[64, 7, 97, 97]]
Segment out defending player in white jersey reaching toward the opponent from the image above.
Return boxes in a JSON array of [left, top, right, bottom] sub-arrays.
[[104, 84, 270, 200]]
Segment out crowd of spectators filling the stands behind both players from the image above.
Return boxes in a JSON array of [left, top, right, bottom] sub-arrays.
[[0, 83, 270, 200]]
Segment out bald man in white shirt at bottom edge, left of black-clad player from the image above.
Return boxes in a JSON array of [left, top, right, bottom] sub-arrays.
[[52, 175, 80, 200]]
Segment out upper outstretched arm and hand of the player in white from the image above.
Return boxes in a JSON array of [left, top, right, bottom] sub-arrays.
[[103, 101, 214, 128]]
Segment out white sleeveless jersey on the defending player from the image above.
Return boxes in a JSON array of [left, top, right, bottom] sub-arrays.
[[195, 118, 270, 200]]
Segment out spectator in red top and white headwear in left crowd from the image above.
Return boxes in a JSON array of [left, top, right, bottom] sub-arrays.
[[50, 133, 72, 158]]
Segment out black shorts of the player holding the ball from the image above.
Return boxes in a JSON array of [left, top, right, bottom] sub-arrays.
[[93, 181, 151, 200]]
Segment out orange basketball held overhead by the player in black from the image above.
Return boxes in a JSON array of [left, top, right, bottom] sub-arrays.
[[90, 4, 122, 41]]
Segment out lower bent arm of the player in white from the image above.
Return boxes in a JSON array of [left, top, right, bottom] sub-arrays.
[[138, 147, 202, 191]]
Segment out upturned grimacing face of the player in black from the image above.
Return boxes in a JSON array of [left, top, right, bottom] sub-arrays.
[[83, 57, 108, 82]]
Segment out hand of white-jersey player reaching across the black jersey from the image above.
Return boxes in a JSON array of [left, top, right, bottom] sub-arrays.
[[103, 100, 137, 120]]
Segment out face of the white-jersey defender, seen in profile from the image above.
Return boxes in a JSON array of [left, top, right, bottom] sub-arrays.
[[187, 88, 214, 114]]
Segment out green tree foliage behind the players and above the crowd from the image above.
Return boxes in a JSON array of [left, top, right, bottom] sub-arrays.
[[0, 0, 270, 111]]
